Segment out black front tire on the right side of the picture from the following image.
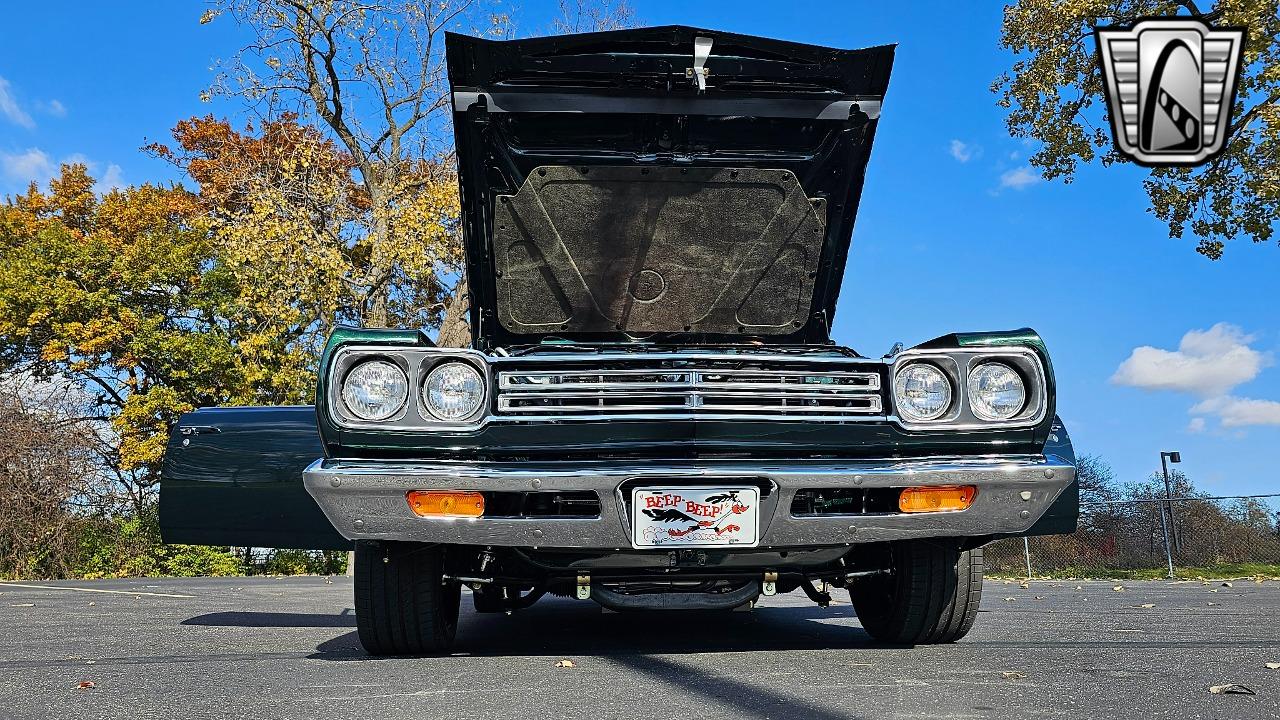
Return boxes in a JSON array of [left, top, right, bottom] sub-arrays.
[[849, 541, 983, 644]]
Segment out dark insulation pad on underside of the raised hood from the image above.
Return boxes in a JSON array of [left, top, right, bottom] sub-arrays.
[[493, 165, 826, 334]]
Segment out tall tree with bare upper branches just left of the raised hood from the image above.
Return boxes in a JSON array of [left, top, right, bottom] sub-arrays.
[[202, 0, 631, 346]]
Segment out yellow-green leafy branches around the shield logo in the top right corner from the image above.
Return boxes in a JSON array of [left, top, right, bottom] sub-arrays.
[[992, 0, 1280, 259]]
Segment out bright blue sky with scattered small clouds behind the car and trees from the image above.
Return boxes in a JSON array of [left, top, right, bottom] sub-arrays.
[[0, 0, 1280, 493]]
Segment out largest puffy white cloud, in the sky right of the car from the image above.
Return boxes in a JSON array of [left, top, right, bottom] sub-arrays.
[[1111, 323, 1271, 397]]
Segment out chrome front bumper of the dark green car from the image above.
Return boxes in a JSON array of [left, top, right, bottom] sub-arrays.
[[303, 456, 1075, 551]]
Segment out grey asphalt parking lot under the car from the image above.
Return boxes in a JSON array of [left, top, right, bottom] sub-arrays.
[[0, 578, 1280, 720]]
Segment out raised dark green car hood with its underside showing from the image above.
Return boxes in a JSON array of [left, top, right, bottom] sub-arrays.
[[447, 27, 893, 348]]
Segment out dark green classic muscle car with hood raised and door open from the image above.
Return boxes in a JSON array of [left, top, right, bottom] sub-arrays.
[[160, 27, 1079, 653]]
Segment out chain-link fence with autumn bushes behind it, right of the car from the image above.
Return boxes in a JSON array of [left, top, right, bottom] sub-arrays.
[[986, 495, 1280, 578]]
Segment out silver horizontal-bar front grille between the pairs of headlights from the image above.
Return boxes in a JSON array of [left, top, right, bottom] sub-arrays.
[[497, 360, 884, 418]]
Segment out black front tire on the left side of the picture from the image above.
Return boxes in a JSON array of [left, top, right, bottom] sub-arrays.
[[356, 541, 462, 655]]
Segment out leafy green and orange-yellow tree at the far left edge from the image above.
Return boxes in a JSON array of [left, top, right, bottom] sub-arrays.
[[0, 165, 315, 499]]
